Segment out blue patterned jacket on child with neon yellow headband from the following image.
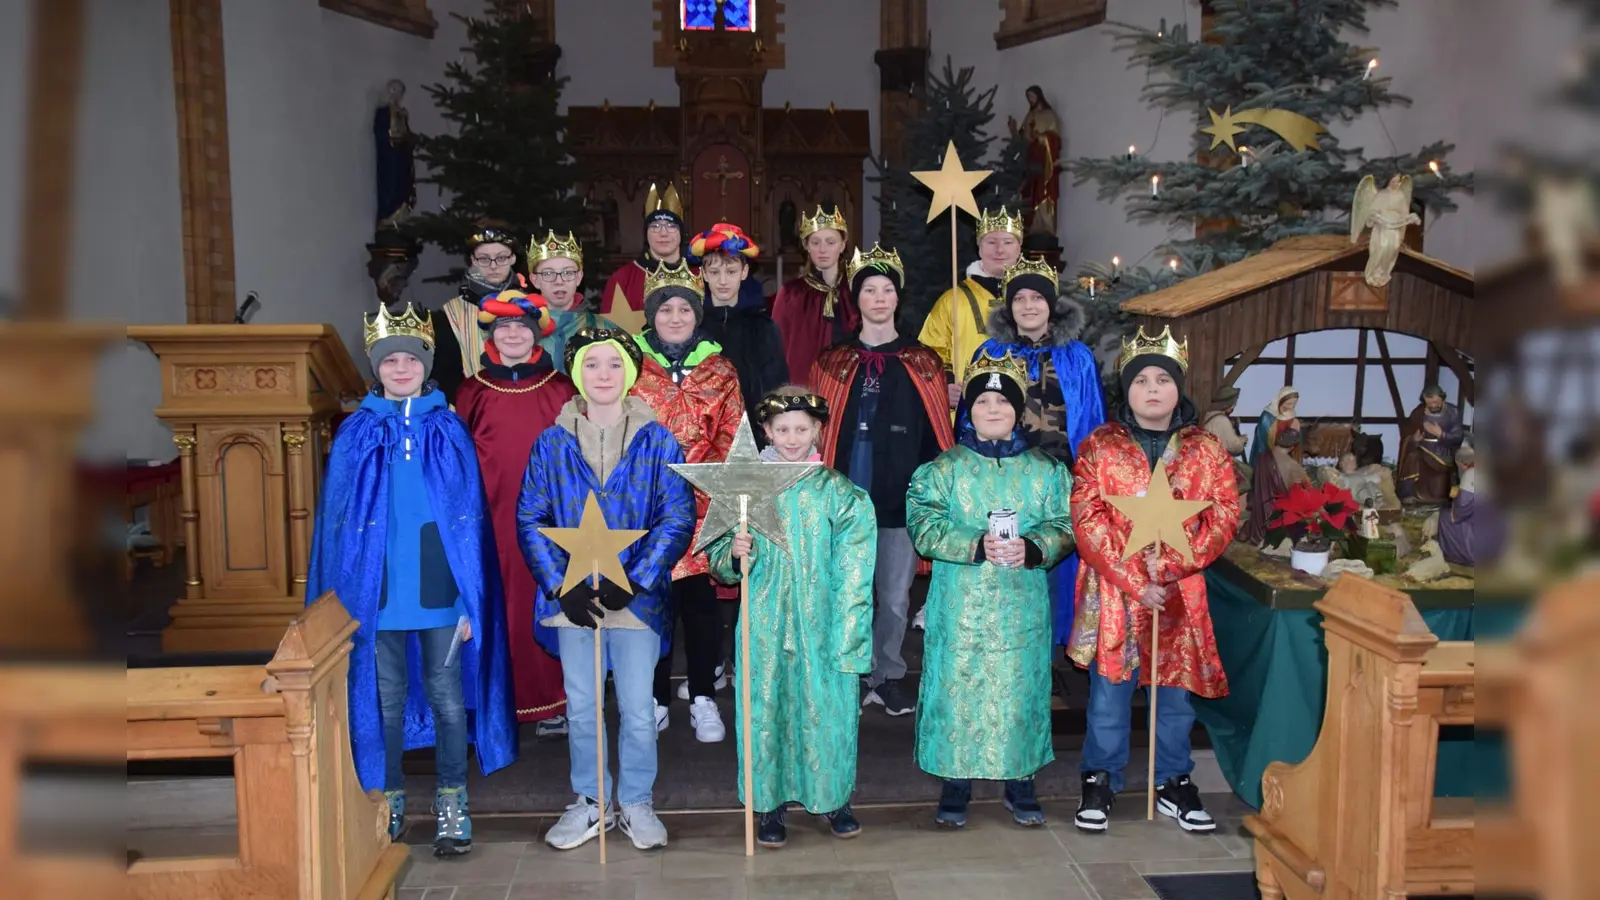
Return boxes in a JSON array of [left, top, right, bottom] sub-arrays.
[[517, 403, 694, 657]]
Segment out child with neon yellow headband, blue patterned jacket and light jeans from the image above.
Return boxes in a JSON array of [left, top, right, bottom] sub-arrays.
[[517, 328, 694, 850]]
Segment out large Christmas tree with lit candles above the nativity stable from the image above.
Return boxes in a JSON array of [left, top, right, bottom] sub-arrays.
[[1069, 0, 1472, 302]]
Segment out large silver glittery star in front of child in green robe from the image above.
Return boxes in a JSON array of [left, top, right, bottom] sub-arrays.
[[672, 413, 822, 552]]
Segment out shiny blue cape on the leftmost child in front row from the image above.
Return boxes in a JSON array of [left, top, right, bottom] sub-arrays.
[[306, 389, 517, 790]]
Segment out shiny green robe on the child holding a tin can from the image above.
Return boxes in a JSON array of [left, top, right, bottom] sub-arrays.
[[906, 445, 1074, 780]]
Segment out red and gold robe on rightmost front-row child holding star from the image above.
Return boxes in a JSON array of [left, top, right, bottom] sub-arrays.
[[1067, 421, 1238, 698]]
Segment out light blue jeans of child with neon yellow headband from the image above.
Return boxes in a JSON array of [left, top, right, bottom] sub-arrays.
[[555, 628, 661, 806]]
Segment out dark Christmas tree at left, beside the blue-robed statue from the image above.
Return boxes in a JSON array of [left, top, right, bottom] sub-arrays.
[[405, 2, 587, 280]]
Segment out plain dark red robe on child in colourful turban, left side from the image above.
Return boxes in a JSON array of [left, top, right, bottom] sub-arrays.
[[456, 344, 578, 722]]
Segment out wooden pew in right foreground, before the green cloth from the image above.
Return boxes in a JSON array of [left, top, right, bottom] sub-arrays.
[[1245, 575, 1474, 900]]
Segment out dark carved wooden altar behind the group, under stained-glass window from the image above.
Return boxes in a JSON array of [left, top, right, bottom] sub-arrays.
[[568, 2, 872, 286]]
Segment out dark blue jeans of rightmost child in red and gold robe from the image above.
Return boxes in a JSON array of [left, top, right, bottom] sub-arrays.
[[1078, 663, 1195, 793]]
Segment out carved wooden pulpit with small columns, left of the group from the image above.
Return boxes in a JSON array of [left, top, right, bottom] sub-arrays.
[[128, 325, 363, 653]]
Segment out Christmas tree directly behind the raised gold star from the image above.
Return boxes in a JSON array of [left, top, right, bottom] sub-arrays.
[[867, 58, 1027, 333]]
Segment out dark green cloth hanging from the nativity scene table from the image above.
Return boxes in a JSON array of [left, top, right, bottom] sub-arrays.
[[1194, 567, 1478, 807]]
